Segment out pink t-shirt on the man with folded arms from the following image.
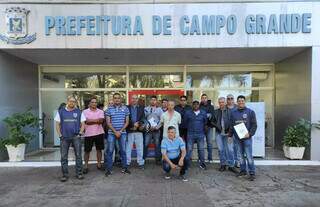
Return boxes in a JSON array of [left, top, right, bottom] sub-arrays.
[[82, 108, 104, 137]]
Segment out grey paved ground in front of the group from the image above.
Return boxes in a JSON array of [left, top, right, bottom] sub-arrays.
[[0, 164, 320, 207]]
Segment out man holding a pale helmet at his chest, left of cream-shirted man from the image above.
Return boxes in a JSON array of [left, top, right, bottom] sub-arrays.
[[144, 96, 163, 164]]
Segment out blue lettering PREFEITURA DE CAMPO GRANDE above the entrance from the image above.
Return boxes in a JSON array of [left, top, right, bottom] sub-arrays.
[[44, 13, 312, 36]]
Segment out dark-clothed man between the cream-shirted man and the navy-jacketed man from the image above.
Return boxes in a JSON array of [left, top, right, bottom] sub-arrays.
[[174, 96, 192, 142]]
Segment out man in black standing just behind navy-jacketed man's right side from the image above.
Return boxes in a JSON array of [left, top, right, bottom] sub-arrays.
[[200, 94, 214, 163]]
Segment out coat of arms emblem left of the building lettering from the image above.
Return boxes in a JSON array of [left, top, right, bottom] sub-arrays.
[[0, 7, 36, 45]]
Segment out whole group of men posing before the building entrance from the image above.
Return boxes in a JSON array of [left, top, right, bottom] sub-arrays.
[[55, 93, 257, 182]]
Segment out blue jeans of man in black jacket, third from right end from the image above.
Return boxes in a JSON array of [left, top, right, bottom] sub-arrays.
[[216, 133, 234, 167]]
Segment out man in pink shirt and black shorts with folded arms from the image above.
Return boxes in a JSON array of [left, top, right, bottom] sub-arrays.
[[83, 97, 104, 174]]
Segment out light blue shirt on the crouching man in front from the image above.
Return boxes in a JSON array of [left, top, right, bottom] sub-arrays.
[[161, 137, 186, 159]]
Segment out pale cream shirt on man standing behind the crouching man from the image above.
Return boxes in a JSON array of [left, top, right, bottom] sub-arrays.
[[160, 111, 181, 137]]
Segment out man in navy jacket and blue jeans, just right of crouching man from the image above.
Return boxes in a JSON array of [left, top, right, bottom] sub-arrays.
[[184, 101, 207, 170]]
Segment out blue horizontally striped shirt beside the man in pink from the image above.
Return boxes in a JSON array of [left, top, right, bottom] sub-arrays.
[[105, 105, 130, 134]]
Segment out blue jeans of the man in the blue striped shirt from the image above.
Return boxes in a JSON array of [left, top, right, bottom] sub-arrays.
[[104, 133, 127, 171]]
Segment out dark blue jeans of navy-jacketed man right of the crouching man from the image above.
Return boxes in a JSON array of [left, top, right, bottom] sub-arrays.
[[186, 134, 204, 166]]
